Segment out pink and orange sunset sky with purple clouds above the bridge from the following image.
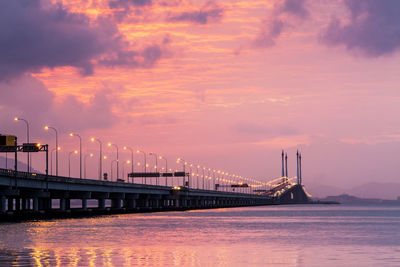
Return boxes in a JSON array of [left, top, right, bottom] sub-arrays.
[[0, 0, 400, 194]]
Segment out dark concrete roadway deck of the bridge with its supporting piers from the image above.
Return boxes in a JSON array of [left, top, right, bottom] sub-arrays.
[[0, 169, 293, 222]]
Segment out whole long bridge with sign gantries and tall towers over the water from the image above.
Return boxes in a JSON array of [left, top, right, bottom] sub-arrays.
[[0, 133, 310, 219]]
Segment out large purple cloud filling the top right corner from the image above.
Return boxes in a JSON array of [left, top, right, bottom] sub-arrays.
[[321, 0, 400, 57]]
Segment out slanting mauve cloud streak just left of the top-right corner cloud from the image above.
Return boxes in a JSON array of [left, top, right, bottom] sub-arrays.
[[253, 0, 310, 48]]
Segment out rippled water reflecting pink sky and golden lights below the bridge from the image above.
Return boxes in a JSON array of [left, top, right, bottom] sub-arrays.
[[0, 205, 400, 266]]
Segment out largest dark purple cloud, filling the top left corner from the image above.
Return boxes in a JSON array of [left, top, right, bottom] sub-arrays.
[[0, 0, 121, 80]]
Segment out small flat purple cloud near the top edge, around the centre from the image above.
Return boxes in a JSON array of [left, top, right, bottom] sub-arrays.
[[167, 3, 224, 25]]
